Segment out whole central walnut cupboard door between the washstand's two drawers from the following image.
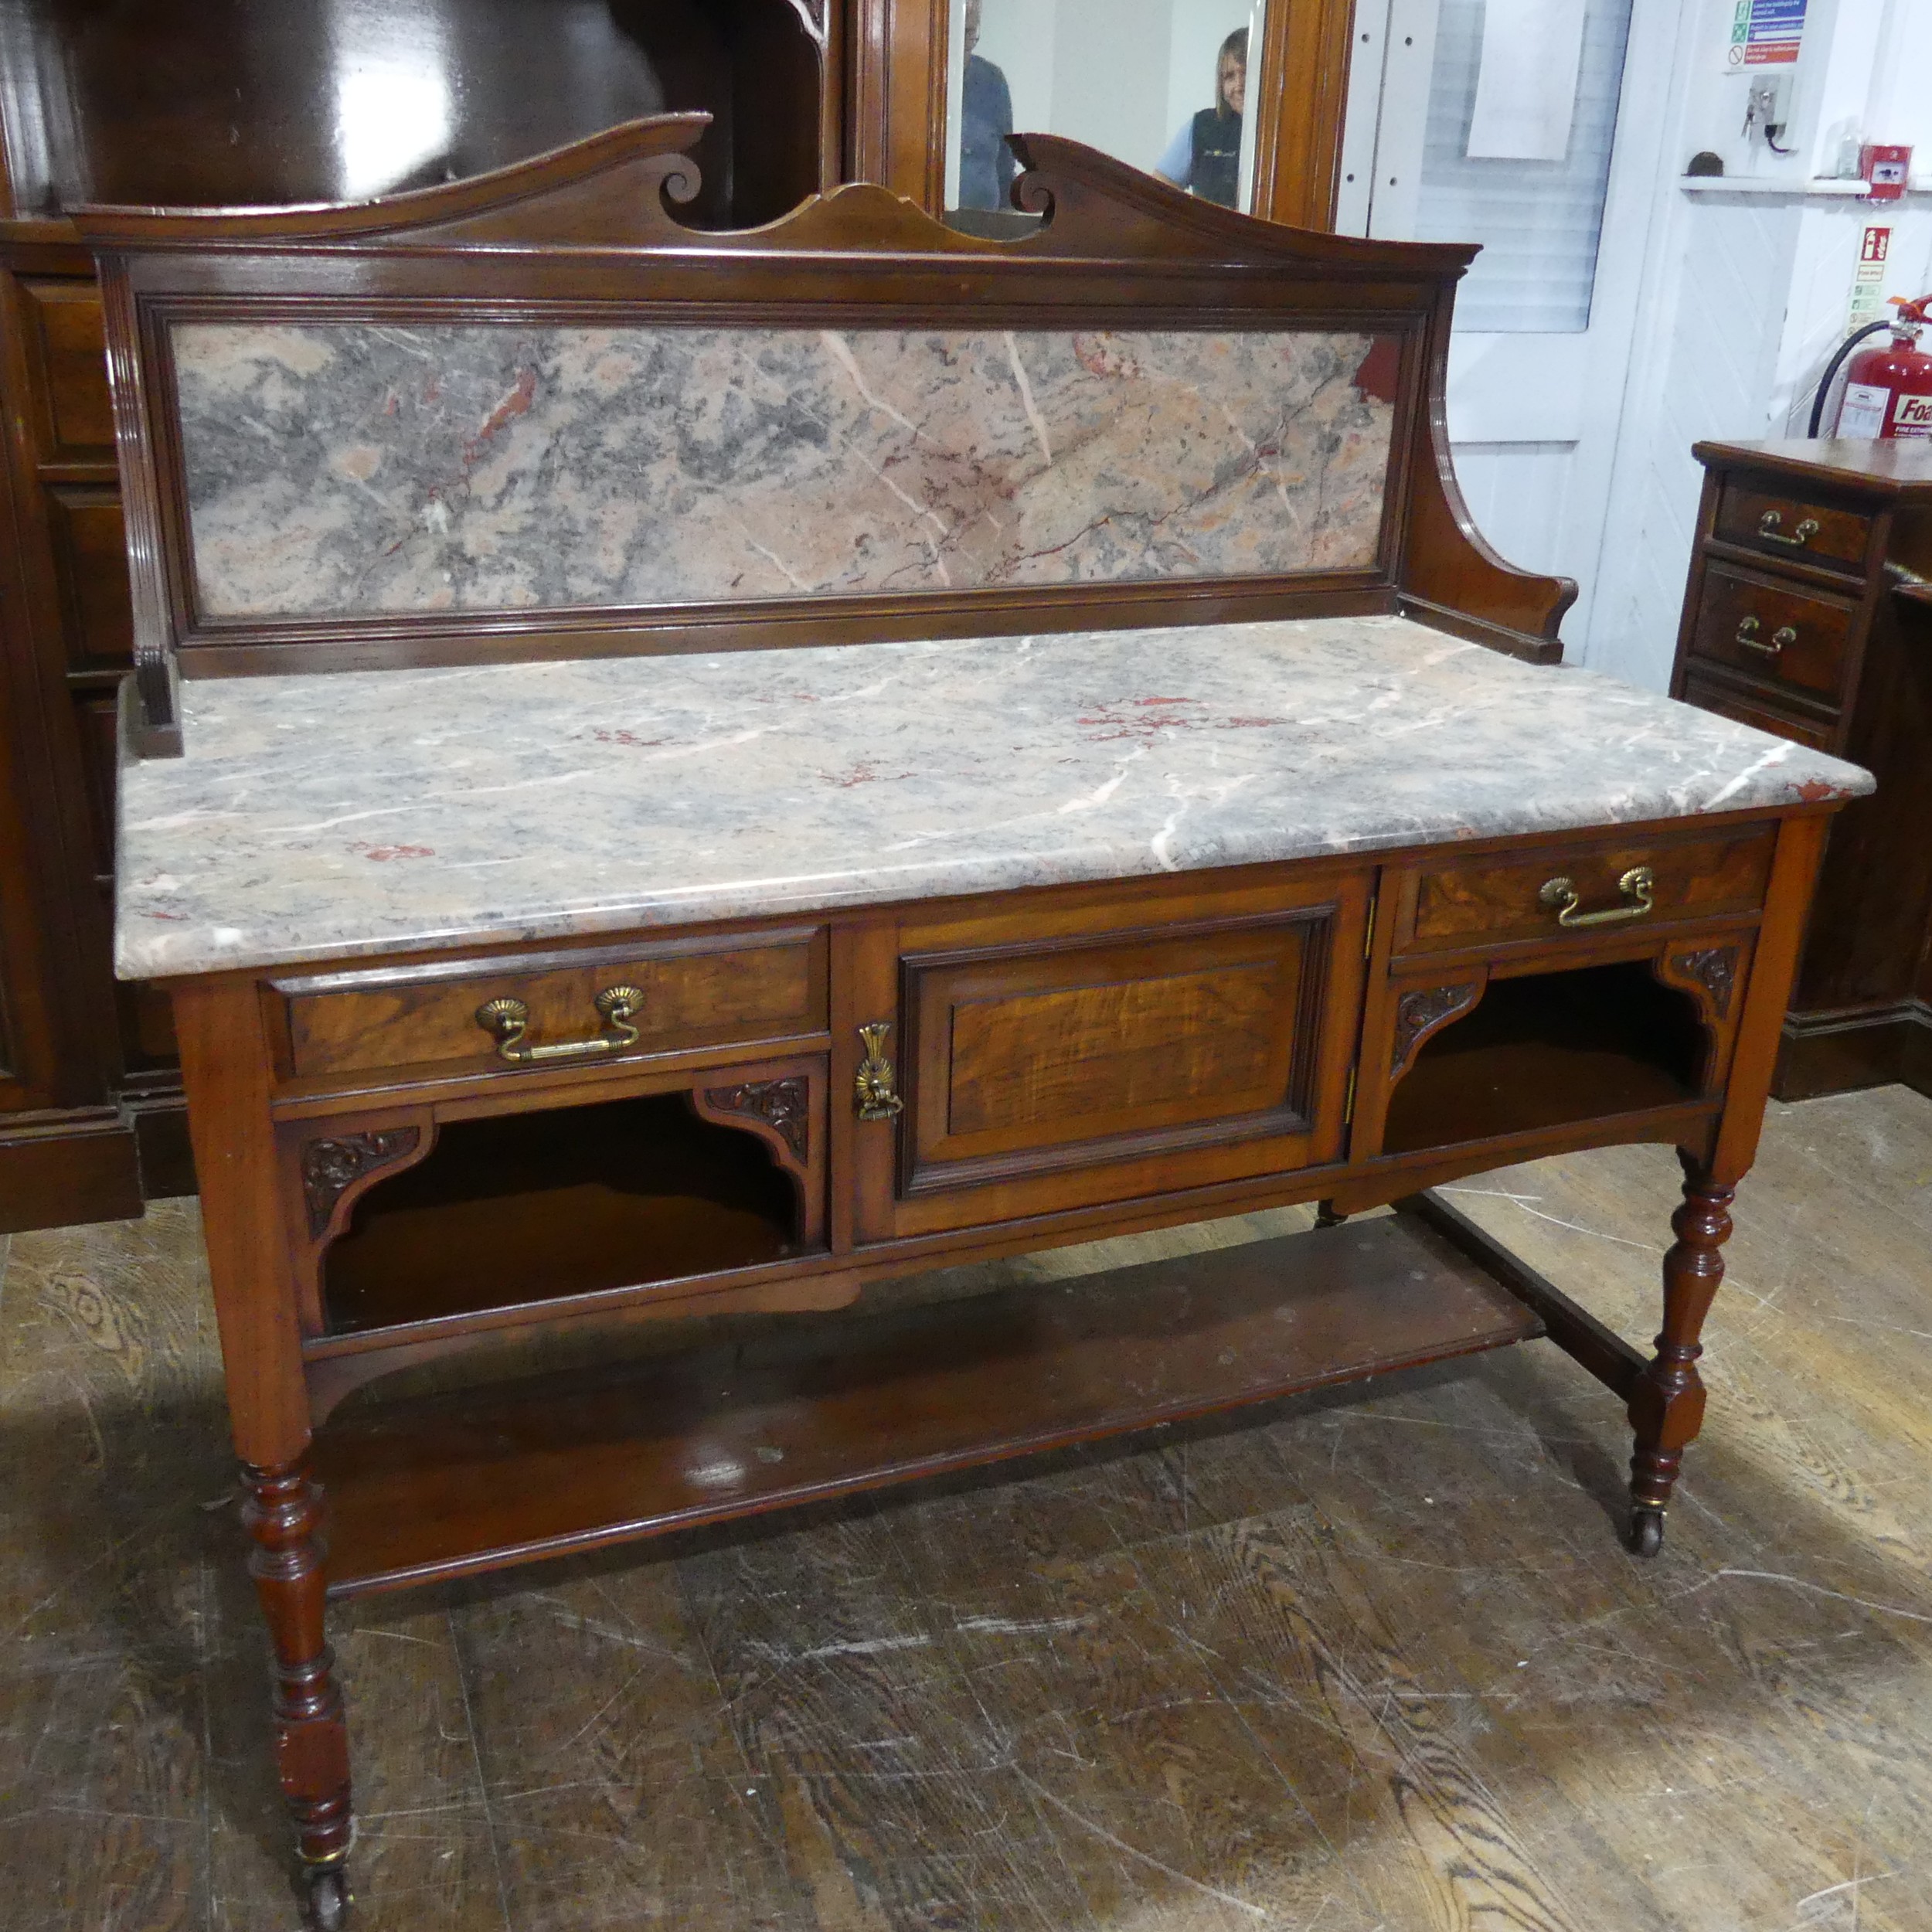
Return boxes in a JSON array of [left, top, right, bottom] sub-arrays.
[[869, 881, 1366, 1233]]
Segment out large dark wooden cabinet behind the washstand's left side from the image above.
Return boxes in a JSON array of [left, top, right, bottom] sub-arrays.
[[0, 0, 846, 1231]]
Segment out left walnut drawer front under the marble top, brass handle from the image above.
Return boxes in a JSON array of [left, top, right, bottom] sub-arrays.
[[274, 927, 825, 1080]]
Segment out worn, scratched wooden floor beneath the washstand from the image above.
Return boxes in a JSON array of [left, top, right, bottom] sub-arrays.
[[0, 1088, 1932, 1932]]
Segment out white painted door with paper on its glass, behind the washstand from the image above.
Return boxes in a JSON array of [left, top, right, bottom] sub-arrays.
[[1337, 0, 1677, 659]]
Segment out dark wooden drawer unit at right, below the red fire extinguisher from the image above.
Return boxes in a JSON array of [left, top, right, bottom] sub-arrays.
[[1672, 440, 1932, 1100]]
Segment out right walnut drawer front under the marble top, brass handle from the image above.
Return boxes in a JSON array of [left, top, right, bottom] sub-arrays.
[[1395, 825, 1776, 958]]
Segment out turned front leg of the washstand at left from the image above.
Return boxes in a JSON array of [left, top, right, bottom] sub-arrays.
[[242, 1463, 350, 1932]]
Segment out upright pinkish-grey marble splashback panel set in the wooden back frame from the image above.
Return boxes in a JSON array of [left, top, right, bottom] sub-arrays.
[[174, 323, 1395, 618]]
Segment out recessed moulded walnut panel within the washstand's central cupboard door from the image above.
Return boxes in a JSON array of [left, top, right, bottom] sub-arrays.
[[900, 906, 1335, 1194]]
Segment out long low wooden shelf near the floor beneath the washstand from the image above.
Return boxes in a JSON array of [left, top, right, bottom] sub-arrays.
[[315, 1216, 1544, 1596]]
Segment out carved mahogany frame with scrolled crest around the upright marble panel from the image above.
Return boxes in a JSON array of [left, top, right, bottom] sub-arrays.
[[77, 105, 1575, 756]]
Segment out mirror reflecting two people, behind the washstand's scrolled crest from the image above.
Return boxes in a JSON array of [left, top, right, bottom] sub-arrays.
[[945, 0, 1267, 236]]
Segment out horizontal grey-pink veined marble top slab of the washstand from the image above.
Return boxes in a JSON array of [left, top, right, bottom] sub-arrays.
[[116, 617, 1872, 980]]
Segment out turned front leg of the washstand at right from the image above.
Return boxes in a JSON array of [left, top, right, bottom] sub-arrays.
[[1631, 1155, 1737, 1557]]
